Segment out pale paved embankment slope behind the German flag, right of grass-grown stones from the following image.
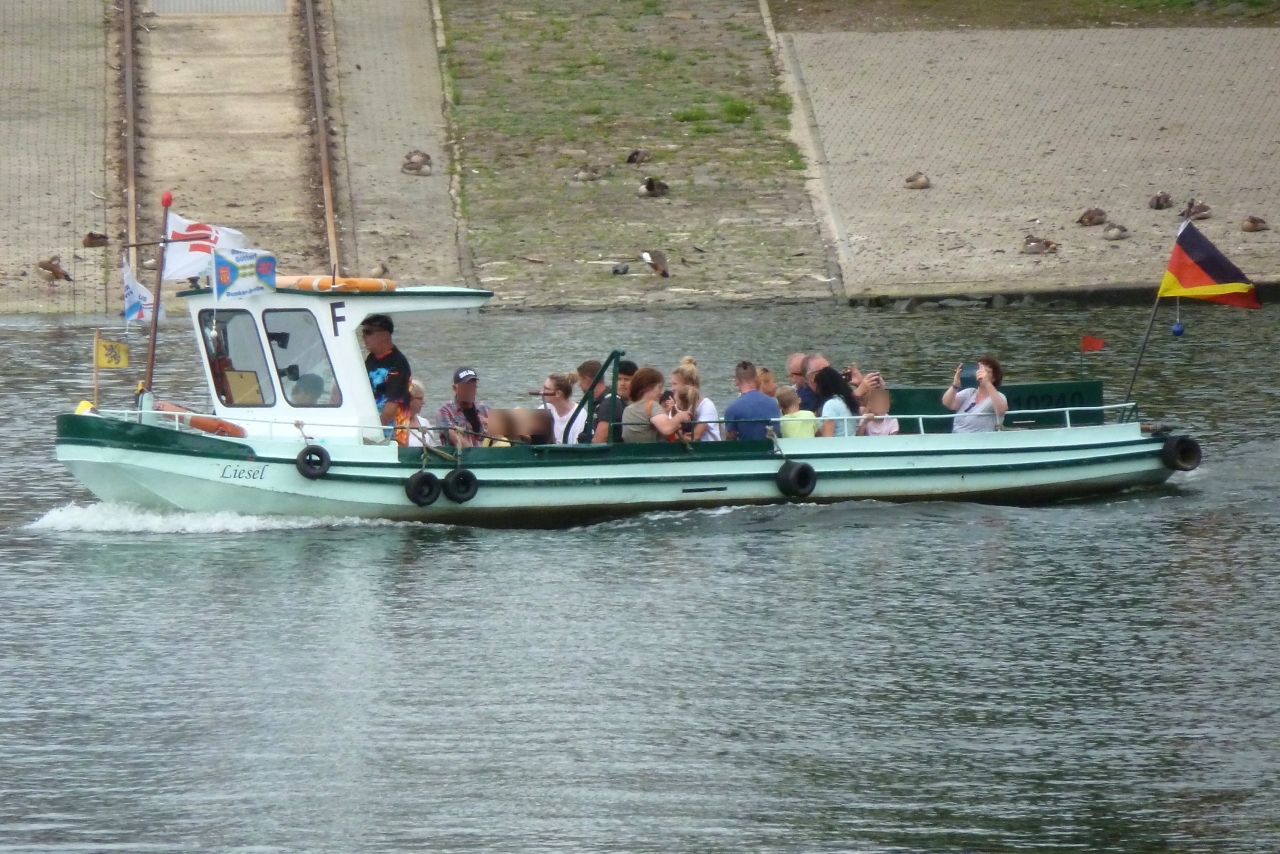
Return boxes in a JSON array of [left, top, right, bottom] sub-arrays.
[[785, 29, 1280, 300]]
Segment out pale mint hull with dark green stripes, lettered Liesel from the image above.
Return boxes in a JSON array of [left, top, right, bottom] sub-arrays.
[[58, 416, 1172, 528]]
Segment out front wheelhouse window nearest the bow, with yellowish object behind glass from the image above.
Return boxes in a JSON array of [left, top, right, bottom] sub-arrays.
[[200, 309, 275, 406]]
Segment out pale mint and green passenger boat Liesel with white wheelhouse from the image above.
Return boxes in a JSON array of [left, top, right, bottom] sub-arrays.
[[58, 280, 1199, 526]]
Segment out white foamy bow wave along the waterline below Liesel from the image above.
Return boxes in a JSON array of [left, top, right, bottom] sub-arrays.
[[27, 504, 416, 534]]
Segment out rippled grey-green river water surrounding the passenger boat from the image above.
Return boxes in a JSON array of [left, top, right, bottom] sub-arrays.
[[0, 306, 1280, 853]]
